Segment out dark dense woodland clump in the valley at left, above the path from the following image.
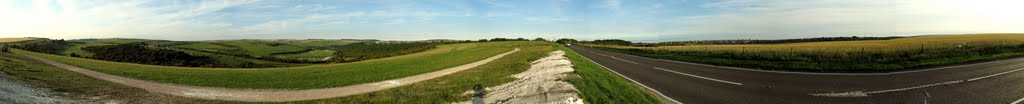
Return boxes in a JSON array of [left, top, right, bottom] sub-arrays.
[[80, 43, 224, 67]]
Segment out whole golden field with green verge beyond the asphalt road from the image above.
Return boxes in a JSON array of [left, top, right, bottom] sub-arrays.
[[587, 34, 1024, 72]]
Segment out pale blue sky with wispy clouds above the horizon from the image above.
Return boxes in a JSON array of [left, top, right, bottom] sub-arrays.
[[0, 0, 1024, 42]]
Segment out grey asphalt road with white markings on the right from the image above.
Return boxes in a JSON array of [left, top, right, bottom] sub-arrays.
[[570, 47, 1024, 104]]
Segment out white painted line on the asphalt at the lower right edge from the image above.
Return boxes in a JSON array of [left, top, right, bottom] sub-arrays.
[[810, 68, 1024, 97]]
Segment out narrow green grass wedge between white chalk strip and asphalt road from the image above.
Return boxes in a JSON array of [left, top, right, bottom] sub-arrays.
[[560, 47, 660, 104]]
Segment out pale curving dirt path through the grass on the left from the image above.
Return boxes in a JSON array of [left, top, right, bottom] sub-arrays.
[[18, 48, 519, 102]]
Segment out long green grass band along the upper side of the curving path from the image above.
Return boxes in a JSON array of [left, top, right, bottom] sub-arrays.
[[16, 42, 530, 89]]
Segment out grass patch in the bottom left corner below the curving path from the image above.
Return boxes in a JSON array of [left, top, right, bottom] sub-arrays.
[[0, 53, 210, 104]]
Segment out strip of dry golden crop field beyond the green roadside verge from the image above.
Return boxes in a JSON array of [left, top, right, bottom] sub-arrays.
[[598, 34, 1024, 52]]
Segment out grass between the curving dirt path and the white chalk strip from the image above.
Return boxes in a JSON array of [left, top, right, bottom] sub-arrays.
[[293, 42, 558, 104]]
